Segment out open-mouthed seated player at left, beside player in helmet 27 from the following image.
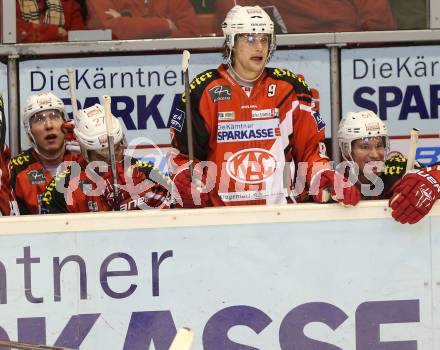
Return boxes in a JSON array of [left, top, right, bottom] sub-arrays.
[[11, 92, 78, 214]]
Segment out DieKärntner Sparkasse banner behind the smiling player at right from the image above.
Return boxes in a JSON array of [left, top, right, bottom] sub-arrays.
[[341, 46, 440, 164]]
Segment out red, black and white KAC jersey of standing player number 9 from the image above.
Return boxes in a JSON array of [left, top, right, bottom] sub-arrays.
[[170, 65, 329, 205]]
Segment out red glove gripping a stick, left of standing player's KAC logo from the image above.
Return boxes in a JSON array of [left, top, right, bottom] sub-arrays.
[[173, 167, 210, 208]]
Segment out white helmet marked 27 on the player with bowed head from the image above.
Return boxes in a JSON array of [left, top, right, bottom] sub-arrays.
[[73, 104, 123, 150]]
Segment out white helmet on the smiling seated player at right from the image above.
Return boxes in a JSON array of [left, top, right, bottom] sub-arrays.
[[338, 110, 389, 160]]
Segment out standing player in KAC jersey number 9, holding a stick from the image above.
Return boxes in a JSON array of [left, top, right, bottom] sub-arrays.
[[171, 6, 360, 207]]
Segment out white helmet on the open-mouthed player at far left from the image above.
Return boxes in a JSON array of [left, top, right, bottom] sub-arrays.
[[23, 92, 66, 133]]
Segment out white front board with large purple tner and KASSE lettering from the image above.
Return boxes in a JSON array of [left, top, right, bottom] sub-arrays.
[[0, 217, 434, 350]]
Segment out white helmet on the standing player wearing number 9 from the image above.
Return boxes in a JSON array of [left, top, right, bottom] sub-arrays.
[[222, 5, 276, 56]]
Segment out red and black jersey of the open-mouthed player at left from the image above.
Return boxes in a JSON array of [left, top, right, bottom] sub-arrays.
[[10, 148, 80, 214]]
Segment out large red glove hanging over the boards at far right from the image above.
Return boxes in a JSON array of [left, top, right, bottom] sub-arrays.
[[389, 169, 440, 224]]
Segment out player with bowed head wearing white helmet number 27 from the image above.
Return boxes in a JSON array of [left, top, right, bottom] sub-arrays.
[[42, 104, 171, 214]]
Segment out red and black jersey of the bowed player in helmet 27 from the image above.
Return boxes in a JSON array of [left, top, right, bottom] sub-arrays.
[[41, 158, 171, 214]]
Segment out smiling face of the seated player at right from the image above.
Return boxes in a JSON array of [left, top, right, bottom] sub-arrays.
[[351, 137, 386, 174]]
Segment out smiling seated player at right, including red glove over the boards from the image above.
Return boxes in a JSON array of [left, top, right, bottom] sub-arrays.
[[338, 110, 440, 223]]
